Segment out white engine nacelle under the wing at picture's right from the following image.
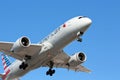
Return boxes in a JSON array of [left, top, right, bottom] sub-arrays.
[[68, 52, 86, 66]]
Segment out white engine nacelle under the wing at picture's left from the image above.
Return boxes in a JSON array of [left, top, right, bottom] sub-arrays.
[[11, 37, 31, 52]]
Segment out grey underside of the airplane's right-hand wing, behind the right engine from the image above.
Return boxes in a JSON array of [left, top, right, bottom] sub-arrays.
[[45, 51, 91, 73]]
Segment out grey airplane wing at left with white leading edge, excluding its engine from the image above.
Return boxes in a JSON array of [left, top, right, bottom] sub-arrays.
[[0, 42, 42, 60]]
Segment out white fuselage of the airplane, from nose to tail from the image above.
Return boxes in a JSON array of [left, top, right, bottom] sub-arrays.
[[6, 16, 91, 80]]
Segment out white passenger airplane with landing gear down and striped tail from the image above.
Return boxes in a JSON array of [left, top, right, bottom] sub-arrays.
[[0, 16, 92, 80]]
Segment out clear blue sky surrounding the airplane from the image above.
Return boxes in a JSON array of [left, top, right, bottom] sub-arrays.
[[0, 0, 120, 80]]
